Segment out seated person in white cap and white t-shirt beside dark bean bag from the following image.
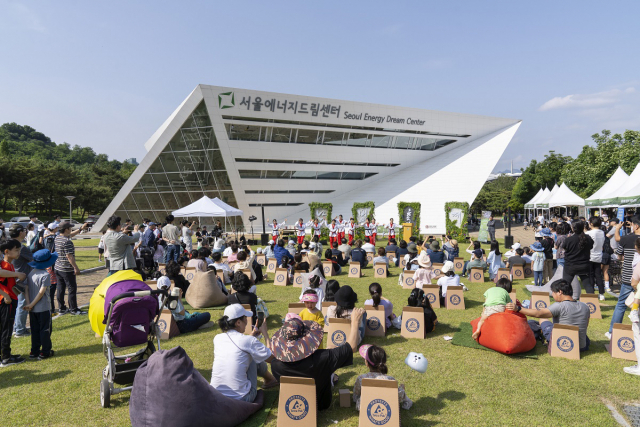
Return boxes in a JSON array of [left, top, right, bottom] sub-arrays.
[[211, 304, 278, 402]]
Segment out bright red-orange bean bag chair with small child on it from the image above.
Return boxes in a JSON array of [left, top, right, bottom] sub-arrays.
[[471, 311, 536, 354]]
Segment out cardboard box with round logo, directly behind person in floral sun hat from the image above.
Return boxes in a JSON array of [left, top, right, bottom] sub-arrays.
[[277, 377, 316, 427]]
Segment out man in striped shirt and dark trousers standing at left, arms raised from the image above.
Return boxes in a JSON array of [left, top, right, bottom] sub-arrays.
[[54, 222, 87, 316]]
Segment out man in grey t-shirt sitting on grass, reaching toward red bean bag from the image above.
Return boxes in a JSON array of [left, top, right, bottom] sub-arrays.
[[506, 279, 591, 352]]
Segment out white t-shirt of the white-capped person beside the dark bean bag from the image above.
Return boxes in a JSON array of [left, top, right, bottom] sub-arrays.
[[211, 330, 271, 399]]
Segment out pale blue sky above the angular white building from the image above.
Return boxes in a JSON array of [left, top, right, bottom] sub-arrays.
[[0, 0, 640, 170]]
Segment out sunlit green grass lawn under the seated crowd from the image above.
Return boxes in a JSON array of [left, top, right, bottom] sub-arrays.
[[0, 242, 638, 426]]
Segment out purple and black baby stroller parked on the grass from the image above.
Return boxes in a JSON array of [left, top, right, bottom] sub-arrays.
[[100, 280, 167, 408]]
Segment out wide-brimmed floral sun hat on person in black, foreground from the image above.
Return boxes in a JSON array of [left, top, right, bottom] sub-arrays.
[[270, 316, 324, 362]]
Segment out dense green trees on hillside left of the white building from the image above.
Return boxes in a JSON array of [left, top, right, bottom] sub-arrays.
[[0, 123, 135, 219]]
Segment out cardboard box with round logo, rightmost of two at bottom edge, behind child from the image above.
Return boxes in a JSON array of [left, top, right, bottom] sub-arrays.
[[358, 378, 400, 427]]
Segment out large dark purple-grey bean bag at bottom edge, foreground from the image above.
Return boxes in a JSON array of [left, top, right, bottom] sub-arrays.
[[129, 347, 264, 427]]
